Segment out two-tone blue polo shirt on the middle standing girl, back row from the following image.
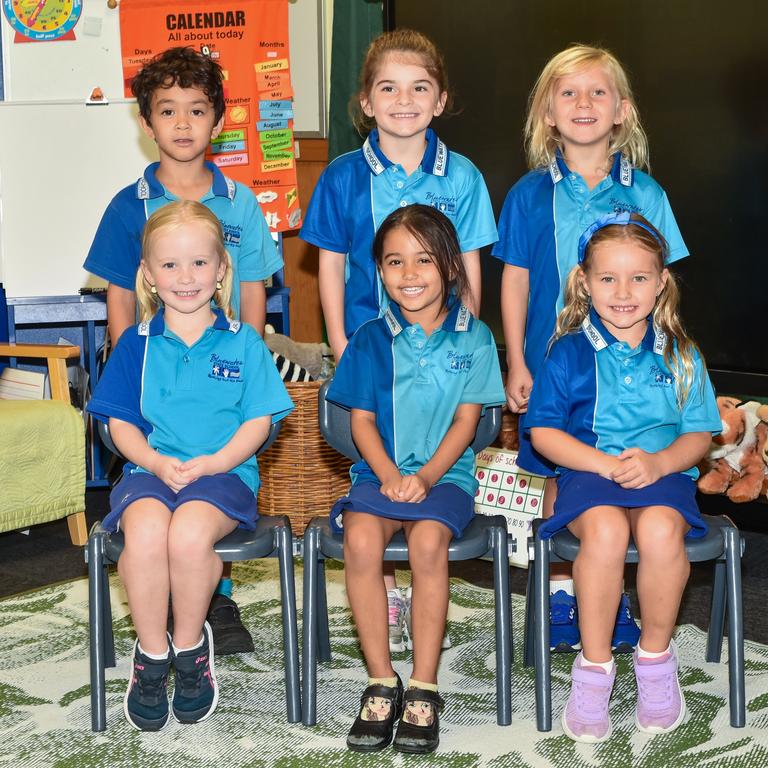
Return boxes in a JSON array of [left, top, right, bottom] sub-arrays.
[[301, 129, 497, 338]]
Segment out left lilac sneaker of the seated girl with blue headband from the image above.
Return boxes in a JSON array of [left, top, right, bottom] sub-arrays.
[[560, 653, 616, 744]]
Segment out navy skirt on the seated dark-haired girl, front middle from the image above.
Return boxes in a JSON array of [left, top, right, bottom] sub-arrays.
[[331, 483, 475, 539]]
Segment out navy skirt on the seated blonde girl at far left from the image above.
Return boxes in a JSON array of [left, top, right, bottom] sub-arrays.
[[102, 472, 259, 531]]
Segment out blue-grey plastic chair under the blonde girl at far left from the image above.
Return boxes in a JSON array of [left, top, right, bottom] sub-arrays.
[[86, 422, 301, 731]]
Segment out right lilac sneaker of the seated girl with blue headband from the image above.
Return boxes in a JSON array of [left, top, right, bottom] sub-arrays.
[[632, 641, 686, 733]]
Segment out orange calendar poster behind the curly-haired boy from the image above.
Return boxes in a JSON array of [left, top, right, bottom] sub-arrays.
[[120, 0, 301, 232]]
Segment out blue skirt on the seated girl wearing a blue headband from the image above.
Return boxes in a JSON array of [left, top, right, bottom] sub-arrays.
[[539, 471, 707, 539]]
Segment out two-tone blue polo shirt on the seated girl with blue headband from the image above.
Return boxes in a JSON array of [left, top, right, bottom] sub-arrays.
[[526, 310, 722, 480]]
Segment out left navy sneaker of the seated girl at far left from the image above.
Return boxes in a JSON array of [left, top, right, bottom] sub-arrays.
[[123, 640, 171, 731]]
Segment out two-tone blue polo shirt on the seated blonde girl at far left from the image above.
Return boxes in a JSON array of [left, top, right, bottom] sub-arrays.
[[88, 309, 293, 494]]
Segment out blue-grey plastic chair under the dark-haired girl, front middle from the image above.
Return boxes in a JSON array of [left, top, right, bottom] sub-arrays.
[[302, 381, 512, 725]]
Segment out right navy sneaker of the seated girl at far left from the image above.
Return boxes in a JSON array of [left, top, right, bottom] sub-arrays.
[[171, 621, 219, 723]]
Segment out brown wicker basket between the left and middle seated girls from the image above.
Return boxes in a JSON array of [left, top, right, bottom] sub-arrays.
[[258, 381, 351, 536]]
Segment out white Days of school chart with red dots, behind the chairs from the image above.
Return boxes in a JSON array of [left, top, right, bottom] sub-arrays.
[[475, 448, 544, 567]]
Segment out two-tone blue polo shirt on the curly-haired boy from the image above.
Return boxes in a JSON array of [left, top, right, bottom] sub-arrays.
[[83, 162, 283, 317]]
